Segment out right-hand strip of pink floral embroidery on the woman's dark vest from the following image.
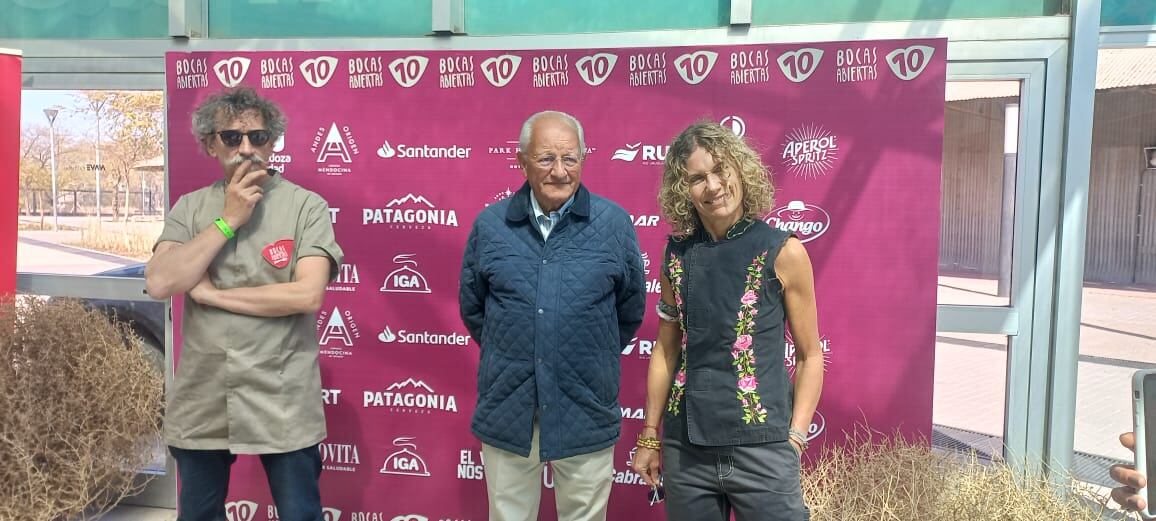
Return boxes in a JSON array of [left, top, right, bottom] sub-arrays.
[[735, 251, 768, 424]]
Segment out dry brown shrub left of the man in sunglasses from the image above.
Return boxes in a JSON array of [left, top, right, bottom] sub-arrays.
[[0, 298, 163, 521]]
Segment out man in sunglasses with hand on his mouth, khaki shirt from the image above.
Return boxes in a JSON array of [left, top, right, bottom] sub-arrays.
[[145, 88, 342, 521]]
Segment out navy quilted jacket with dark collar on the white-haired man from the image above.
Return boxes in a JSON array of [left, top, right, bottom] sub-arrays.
[[459, 184, 646, 461]]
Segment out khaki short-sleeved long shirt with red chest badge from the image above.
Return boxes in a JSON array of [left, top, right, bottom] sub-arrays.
[[157, 174, 342, 454]]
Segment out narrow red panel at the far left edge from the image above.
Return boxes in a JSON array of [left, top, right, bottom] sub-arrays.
[[0, 49, 21, 298]]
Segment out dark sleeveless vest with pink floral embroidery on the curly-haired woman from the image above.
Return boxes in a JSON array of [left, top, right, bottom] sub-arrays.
[[664, 219, 793, 446]]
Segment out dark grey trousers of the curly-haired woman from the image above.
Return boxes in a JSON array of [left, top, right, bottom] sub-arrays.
[[662, 434, 810, 521]]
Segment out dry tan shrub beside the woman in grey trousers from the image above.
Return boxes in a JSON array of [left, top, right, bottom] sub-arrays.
[[802, 427, 1113, 521]]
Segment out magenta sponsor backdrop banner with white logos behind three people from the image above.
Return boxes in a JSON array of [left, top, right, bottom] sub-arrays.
[[166, 39, 946, 521]]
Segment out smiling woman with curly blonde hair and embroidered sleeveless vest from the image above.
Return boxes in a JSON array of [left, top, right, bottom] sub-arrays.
[[633, 122, 823, 521]]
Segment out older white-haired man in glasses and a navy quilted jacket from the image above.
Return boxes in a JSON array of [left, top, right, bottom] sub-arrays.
[[460, 111, 645, 521]]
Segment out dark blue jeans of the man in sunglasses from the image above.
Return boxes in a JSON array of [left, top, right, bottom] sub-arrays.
[[169, 445, 323, 521]]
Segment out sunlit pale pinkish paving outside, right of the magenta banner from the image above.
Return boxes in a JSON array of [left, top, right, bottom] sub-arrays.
[[934, 277, 1156, 460]]
